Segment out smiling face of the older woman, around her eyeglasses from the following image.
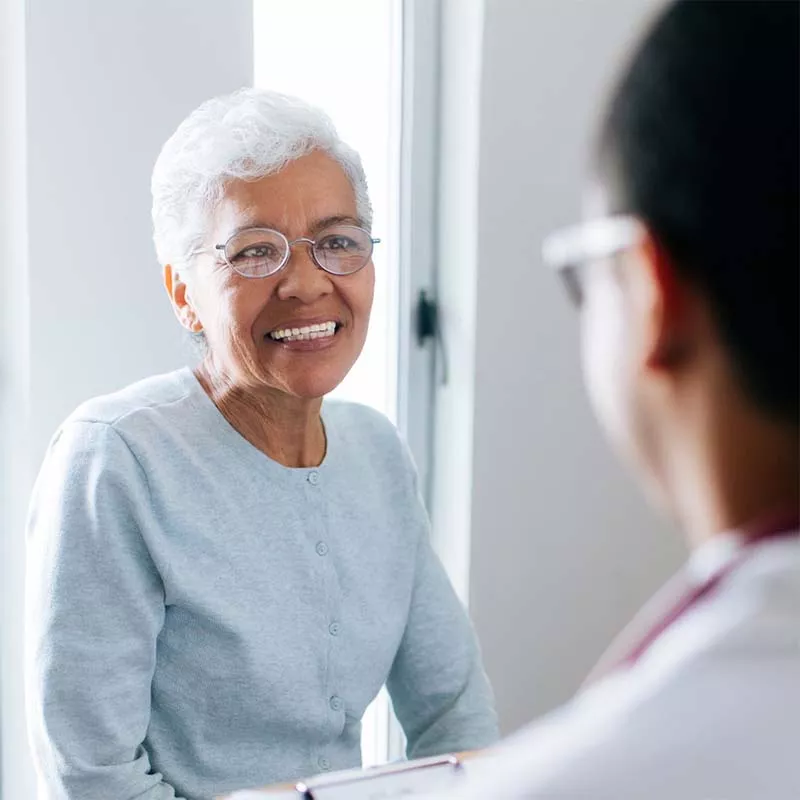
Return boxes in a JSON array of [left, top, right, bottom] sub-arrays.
[[168, 151, 375, 399]]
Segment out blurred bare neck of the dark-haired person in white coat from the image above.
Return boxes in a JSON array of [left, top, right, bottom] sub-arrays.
[[662, 376, 800, 548]]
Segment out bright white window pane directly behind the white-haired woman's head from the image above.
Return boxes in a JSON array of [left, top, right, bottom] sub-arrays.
[[254, 0, 400, 421]]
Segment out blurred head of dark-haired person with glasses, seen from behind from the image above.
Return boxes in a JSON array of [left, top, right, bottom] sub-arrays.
[[545, 0, 800, 532]]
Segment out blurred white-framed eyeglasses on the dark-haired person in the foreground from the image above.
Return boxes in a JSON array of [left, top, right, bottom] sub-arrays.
[[542, 215, 645, 306]]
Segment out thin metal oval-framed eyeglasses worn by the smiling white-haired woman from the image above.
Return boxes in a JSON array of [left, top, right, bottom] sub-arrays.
[[190, 225, 380, 278]]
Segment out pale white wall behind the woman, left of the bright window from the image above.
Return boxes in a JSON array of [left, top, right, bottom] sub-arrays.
[[0, 0, 253, 800]]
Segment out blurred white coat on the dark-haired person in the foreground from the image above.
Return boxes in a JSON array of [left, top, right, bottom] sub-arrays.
[[440, 535, 800, 800]]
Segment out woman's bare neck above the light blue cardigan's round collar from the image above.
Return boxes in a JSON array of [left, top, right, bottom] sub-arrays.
[[195, 358, 327, 467]]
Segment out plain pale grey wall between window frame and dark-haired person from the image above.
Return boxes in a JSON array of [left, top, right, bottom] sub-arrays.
[[470, 0, 683, 731]]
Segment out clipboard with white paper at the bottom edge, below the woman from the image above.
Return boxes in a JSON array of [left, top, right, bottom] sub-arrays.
[[226, 755, 464, 800]]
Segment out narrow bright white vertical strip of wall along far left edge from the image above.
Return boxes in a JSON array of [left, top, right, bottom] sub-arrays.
[[0, 0, 34, 798]]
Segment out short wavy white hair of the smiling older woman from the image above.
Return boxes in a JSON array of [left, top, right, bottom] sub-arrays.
[[151, 89, 372, 265]]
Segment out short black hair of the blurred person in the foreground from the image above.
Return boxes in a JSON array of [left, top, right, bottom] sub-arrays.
[[597, 0, 800, 424]]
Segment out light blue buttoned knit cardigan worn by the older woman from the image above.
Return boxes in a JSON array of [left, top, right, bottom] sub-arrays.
[[27, 369, 497, 800]]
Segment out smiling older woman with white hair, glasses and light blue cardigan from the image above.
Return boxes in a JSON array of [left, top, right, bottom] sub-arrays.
[[28, 89, 497, 800]]
